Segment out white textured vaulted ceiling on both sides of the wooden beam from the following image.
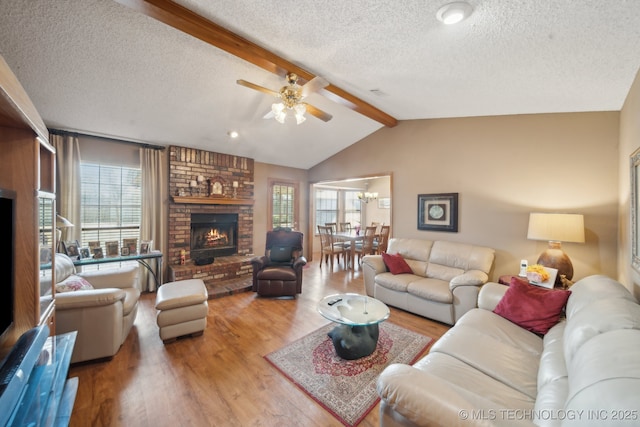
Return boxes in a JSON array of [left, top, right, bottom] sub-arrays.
[[0, 0, 640, 169]]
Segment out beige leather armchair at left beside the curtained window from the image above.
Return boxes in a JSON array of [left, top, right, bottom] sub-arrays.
[[55, 254, 140, 363]]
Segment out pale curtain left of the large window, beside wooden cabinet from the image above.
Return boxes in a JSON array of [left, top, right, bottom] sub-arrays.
[[50, 134, 82, 247]]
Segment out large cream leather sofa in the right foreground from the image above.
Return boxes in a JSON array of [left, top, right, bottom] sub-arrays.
[[377, 276, 640, 426]]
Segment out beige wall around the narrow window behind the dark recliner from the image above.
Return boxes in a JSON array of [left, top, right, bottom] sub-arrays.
[[253, 162, 311, 255]]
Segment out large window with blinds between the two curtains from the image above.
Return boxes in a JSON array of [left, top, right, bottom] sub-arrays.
[[80, 163, 142, 251]]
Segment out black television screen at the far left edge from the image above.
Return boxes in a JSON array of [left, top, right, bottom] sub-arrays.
[[0, 188, 16, 337]]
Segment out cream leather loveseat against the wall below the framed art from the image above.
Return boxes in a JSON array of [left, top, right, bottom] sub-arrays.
[[362, 238, 495, 325]]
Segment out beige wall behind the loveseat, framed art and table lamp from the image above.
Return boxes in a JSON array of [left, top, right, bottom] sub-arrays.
[[309, 112, 620, 280]]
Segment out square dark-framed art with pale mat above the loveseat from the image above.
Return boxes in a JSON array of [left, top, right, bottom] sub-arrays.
[[418, 193, 458, 232]]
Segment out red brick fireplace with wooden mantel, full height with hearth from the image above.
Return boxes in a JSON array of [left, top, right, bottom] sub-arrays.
[[167, 146, 254, 297]]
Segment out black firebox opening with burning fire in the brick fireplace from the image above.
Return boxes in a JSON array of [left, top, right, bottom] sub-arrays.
[[191, 213, 238, 261]]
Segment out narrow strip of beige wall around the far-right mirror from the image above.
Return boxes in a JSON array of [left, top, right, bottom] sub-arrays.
[[618, 69, 640, 297]]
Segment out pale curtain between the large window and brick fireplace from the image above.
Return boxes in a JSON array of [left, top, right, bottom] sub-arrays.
[[140, 147, 169, 291]]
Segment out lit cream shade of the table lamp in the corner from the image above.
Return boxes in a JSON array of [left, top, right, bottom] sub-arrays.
[[527, 213, 584, 243]]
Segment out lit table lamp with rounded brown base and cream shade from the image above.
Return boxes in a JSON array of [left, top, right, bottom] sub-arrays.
[[527, 213, 584, 285]]
